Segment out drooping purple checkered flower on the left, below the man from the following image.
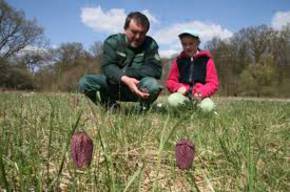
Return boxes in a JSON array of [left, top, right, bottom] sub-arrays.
[[71, 131, 94, 168]]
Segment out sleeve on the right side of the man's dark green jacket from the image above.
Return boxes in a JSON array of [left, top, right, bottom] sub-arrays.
[[126, 42, 162, 79]]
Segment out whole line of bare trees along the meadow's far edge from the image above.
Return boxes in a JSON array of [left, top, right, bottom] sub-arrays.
[[0, 0, 290, 97]]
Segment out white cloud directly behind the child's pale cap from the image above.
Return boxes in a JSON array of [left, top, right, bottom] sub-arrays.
[[153, 21, 233, 57]]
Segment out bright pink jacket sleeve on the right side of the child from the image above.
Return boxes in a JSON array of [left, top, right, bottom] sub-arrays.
[[193, 59, 219, 98]]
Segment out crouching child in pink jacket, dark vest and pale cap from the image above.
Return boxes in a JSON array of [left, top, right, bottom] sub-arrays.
[[166, 30, 219, 110]]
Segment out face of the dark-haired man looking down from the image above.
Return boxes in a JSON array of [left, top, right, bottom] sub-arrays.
[[125, 19, 147, 48]]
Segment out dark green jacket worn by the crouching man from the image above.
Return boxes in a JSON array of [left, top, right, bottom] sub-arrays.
[[102, 33, 162, 83]]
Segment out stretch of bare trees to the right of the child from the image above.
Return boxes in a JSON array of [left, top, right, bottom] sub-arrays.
[[206, 24, 290, 97]]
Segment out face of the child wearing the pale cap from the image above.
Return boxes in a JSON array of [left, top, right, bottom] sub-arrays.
[[180, 36, 199, 57]]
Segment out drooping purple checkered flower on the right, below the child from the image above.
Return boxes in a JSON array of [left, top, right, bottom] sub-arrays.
[[175, 139, 195, 170]]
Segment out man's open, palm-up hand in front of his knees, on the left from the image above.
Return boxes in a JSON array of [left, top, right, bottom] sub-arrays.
[[121, 75, 149, 99]]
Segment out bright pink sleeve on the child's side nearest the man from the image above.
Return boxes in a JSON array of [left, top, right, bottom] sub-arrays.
[[166, 59, 189, 93]]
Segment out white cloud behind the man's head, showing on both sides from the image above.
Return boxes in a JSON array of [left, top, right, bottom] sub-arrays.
[[81, 6, 158, 33]]
